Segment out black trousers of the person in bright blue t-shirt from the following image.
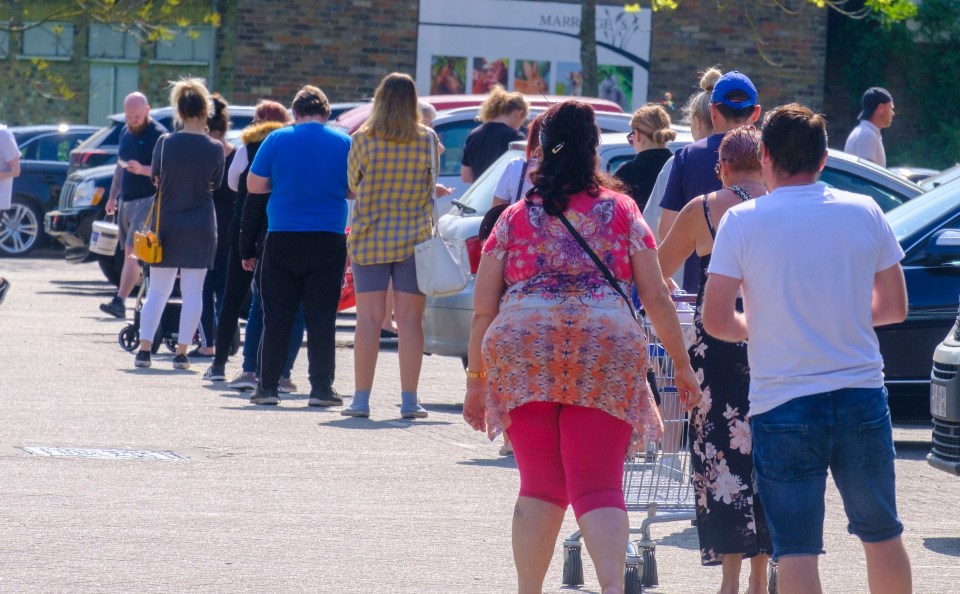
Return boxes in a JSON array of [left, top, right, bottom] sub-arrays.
[[258, 231, 347, 389]]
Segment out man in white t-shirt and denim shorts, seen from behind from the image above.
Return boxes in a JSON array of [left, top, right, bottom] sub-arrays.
[[703, 104, 911, 594]]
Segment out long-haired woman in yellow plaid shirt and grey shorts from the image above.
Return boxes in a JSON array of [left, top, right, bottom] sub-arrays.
[[341, 73, 439, 418]]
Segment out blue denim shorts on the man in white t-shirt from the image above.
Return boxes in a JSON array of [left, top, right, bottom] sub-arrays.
[[750, 388, 903, 558]]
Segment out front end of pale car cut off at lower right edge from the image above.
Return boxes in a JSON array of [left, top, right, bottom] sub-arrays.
[[927, 298, 960, 476]]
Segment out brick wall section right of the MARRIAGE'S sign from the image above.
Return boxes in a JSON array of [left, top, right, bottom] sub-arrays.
[[649, 0, 827, 117]]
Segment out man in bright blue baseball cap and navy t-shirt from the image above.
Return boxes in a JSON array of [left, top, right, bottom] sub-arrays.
[[658, 70, 760, 294]]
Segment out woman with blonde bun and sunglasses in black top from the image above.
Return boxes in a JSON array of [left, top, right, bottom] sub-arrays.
[[614, 103, 677, 211]]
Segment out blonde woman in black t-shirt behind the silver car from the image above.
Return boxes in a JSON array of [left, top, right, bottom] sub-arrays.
[[460, 85, 530, 184]]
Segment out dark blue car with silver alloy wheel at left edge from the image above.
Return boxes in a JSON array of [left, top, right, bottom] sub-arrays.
[[0, 124, 98, 256]]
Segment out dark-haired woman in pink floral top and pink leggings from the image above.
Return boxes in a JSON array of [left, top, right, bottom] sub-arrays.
[[463, 101, 700, 593]]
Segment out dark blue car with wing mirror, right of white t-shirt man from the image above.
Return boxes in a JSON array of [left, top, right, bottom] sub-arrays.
[[877, 181, 960, 412]]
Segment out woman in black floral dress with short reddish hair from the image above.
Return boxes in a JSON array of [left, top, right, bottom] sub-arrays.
[[659, 126, 773, 594]]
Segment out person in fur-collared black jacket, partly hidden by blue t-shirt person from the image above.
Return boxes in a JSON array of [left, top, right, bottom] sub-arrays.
[[204, 101, 295, 390]]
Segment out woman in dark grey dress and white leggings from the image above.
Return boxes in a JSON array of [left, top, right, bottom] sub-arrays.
[[134, 78, 224, 369]]
